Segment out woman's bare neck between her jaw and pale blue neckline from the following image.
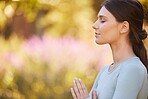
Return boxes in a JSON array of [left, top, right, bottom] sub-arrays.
[[110, 39, 136, 64]]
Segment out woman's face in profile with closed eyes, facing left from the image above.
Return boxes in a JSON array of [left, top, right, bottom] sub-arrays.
[[92, 6, 121, 44]]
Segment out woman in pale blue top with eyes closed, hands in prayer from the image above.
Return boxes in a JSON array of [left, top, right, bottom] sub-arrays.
[[71, 0, 148, 99]]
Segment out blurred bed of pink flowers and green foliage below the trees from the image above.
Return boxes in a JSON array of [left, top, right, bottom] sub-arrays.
[[0, 36, 112, 99]]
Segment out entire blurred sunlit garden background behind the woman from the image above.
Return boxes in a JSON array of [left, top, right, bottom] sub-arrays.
[[0, 0, 148, 99]]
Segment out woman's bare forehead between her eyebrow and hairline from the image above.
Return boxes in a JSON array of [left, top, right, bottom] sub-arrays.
[[98, 6, 115, 19]]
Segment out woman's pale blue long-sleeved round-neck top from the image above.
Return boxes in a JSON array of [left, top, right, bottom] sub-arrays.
[[87, 57, 148, 99]]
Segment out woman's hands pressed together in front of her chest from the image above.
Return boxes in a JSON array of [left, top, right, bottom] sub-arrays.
[[71, 78, 98, 99]]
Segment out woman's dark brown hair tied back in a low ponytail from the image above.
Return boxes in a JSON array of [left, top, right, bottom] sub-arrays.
[[102, 0, 148, 70]]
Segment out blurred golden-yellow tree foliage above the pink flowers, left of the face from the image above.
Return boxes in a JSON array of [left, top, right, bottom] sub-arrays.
[[0, 0, 94, 39]]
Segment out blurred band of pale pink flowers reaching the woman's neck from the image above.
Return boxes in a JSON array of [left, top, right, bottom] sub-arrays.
[[22, 36, 112, 70]]
